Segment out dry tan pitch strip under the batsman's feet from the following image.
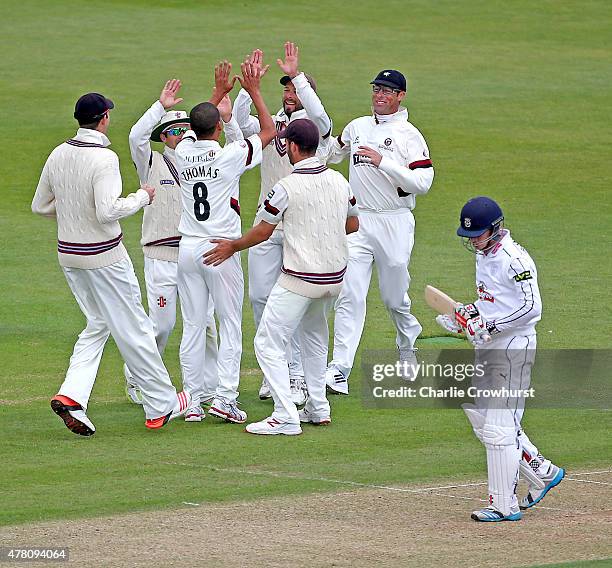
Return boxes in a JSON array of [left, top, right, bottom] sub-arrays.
[[0, 470, 612, 568]]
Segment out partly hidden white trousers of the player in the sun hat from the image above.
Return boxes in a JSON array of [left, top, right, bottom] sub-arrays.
[[125, 256, 218, 404]]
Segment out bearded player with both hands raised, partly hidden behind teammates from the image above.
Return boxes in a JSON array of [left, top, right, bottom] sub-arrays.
[[234, 42, 332, 405]]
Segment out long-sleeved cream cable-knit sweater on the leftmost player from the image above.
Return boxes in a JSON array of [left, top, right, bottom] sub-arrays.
[[32, 128, 149, 269]]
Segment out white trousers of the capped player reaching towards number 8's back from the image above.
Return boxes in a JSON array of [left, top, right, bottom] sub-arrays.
[[255, 284, 335, 424]]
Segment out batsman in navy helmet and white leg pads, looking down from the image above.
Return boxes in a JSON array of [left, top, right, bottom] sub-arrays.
[[436, 197, 565, 522]]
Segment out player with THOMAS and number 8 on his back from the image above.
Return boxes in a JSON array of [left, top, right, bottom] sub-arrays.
[[175, 62, 276, 423]]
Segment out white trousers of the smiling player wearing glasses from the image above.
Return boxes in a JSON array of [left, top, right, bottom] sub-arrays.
[[331, 209, 423, 377]]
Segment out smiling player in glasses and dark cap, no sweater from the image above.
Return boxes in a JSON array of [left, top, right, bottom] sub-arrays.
[[326, 69, 434, 394]]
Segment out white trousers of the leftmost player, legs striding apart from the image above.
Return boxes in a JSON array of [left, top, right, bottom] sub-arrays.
[[58, 258, 177, 419]]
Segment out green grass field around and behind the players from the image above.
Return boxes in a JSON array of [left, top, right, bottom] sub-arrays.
[[0, 0, 612, 564]]
